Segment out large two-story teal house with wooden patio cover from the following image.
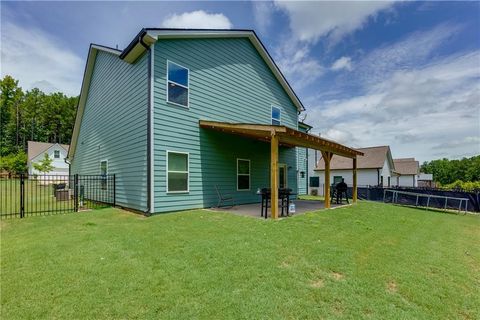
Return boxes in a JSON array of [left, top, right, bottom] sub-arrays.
[[68, 29, 361, 215]]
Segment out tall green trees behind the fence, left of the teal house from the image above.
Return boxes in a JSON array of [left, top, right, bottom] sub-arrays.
[[0, 75, 78, 173]]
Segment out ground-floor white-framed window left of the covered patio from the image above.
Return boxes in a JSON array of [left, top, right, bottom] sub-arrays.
[[167, 151, 189, 193]]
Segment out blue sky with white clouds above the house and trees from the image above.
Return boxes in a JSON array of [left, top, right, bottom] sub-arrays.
[[0, 1, 480, 161]]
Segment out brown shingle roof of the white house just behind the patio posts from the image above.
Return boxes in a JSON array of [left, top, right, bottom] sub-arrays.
[[314, 146, 394, 171]]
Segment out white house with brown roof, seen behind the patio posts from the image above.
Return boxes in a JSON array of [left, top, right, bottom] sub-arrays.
[[310, 146, 395, 194]]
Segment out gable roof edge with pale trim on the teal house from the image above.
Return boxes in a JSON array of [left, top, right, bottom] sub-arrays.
[[67, 28, 305, 160]]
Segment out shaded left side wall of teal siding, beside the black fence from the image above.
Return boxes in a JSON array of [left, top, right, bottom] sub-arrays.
[[71, 51, 148, 211]]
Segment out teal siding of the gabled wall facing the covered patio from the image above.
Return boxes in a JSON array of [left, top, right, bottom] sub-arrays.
[[153, 39, 297, 212]]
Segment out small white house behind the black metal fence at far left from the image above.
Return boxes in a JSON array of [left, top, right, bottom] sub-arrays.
[[27, 141, 69, 175]]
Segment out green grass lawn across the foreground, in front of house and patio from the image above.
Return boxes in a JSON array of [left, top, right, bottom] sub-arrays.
[[1, 202, 480, 319]]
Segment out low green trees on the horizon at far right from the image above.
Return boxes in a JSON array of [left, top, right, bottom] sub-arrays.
[[420, 155, 480, 186]]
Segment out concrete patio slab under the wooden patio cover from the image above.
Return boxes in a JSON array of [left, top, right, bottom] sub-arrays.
[[210, 200, 351, 219]]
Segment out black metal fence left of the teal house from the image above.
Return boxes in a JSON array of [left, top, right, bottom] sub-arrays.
[[0, 174, 115, 219]]
